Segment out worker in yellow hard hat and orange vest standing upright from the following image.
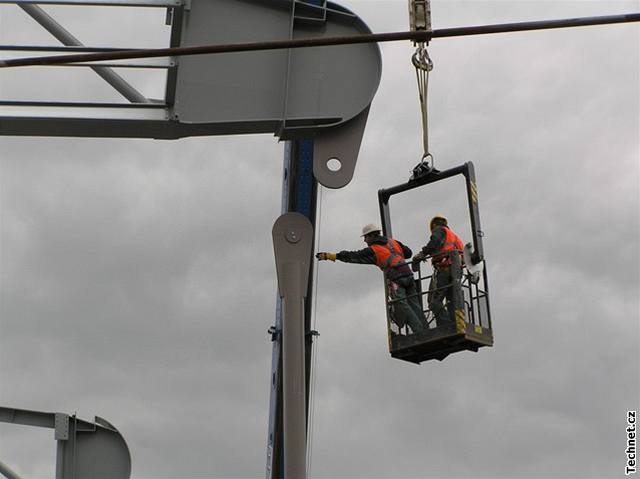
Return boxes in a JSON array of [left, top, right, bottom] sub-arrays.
[[413, 215, 464, 327]]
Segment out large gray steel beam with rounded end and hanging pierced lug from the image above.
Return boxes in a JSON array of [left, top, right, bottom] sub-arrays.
[[0, 0, 382, 184]]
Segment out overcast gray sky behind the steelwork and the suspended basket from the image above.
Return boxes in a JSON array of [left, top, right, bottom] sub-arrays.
[[0, 0, 640, 479]]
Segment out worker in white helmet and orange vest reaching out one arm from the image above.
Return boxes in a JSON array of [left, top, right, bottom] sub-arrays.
[[316, 224, 428, 333]]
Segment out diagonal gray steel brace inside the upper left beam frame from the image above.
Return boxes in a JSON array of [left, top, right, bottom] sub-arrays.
[[18, 3, 150, 103]]
